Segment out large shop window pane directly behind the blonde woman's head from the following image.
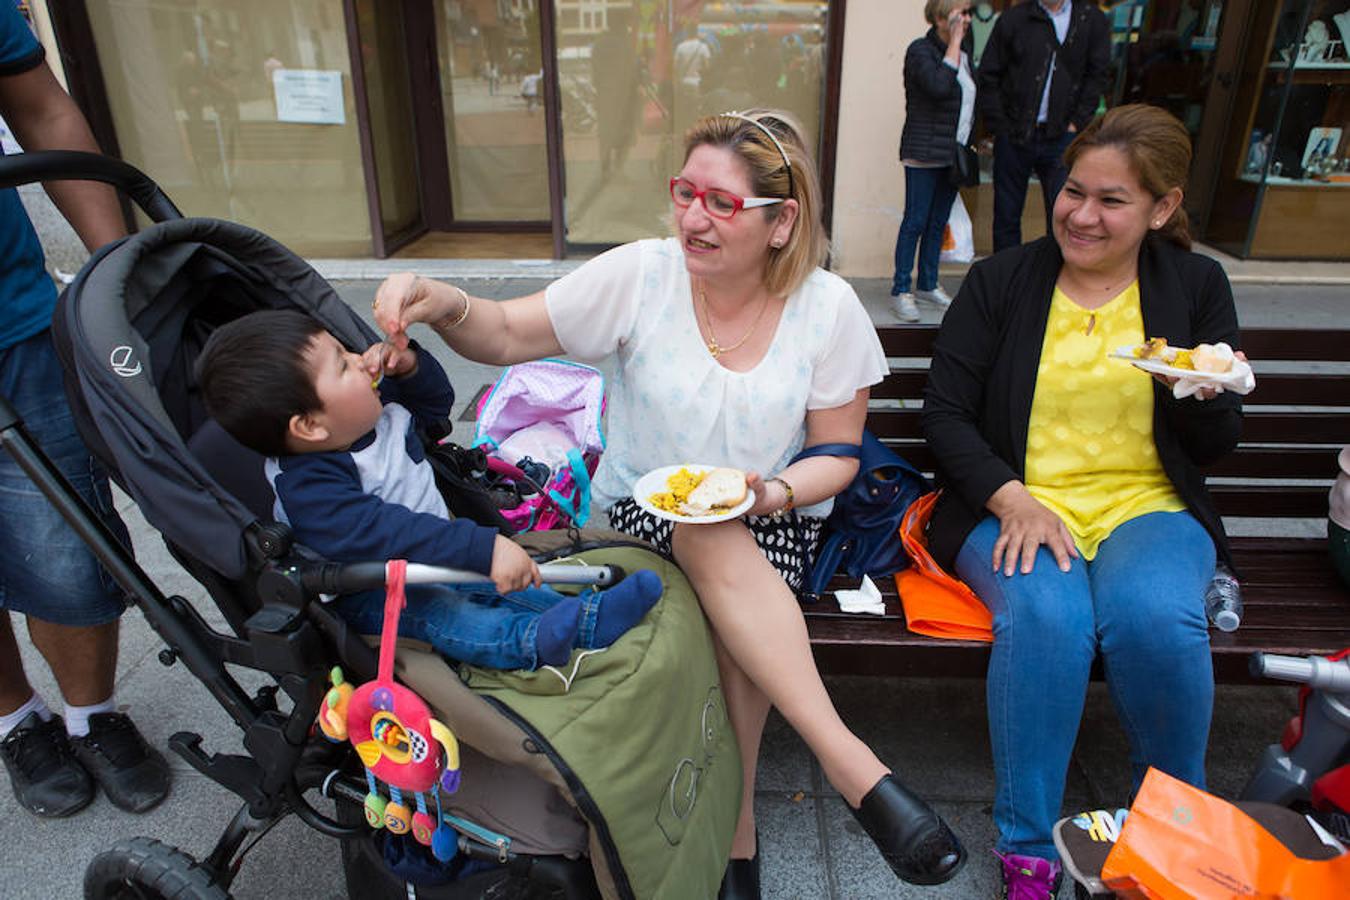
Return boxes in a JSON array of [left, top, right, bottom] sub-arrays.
[[555, 0, 829, 244]]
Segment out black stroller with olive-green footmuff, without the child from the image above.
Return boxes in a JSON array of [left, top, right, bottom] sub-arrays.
[[0, 154, 741, 900]]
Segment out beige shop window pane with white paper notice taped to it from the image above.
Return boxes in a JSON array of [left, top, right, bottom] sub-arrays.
[[86, 0, 370, 256]]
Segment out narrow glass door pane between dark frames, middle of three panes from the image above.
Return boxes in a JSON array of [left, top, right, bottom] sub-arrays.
[[436, 0, 549, 221]]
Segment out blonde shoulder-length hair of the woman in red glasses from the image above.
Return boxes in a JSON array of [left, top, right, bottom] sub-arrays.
[[684, 109, 829, 297]]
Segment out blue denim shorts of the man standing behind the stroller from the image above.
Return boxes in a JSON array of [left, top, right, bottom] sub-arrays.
[[0, 331, 130, 626]]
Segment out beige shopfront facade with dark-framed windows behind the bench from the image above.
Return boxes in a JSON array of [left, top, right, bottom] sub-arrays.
[[30, 0, 1350, 277]]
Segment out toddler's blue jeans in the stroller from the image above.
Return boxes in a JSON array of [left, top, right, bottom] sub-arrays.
[[333, 584, 599, 669]]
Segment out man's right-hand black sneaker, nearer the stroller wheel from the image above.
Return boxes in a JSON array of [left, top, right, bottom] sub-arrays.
[[70, 712, 169, 812]]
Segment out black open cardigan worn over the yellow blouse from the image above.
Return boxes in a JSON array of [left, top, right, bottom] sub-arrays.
[[923, 233, 1242, 571]]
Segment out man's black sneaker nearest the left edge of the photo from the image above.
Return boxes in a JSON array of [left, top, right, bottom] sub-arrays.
[[0, 712, 93, 819]]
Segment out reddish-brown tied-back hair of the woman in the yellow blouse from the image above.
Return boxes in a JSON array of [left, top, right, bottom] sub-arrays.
[[1064, 103, 1191, 250]]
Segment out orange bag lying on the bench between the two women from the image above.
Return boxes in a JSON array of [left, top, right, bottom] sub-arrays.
[[895, 491, 994, 642]]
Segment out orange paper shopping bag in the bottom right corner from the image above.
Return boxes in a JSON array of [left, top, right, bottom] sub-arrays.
[[1102, 769, 1350, 900]]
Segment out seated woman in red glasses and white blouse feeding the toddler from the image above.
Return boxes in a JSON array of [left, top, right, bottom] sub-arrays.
[[375, 111, 965, 897]]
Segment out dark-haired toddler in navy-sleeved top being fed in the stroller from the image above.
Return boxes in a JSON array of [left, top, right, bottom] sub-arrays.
[[197, 310, 662, 669]]
